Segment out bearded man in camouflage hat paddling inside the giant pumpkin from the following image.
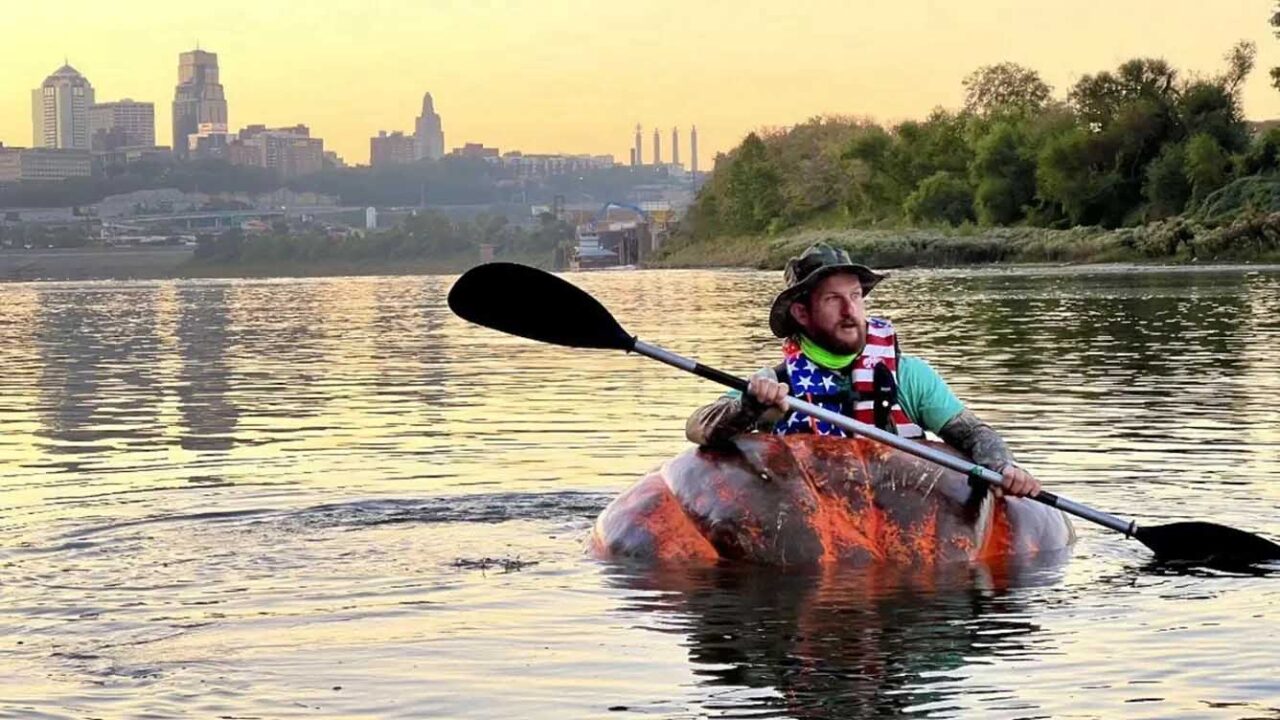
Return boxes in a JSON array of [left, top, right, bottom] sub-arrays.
[[685, 242, 1039, 496]]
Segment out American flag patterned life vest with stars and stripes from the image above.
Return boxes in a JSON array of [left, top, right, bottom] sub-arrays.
[[773, 318, 924, 438]]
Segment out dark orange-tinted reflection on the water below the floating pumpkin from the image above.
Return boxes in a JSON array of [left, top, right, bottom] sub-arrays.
[[607, 553, 1066, 717]]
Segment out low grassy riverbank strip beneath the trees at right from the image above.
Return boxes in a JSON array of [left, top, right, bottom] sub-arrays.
[[646, 213, 1280, 269]]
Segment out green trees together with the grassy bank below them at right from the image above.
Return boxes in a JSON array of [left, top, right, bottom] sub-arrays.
[[649, 36, 1280, 268]]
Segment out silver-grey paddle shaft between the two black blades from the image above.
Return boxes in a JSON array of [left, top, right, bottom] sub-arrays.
[[632, 340, 1138, 536]]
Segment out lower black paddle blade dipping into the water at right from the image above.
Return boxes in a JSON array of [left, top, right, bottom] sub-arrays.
[[1134, 523, 1280, 565]]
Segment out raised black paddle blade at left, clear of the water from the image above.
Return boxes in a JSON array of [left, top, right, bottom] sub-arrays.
[[449, 263, 635, 351]]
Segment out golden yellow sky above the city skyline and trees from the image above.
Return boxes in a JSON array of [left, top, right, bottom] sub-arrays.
[[0, 0, 1280, 168]]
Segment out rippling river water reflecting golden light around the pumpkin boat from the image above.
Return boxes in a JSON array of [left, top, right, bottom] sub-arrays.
[[0, 268, 1280, 719]]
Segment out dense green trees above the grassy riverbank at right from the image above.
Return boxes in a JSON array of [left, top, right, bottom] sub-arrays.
[[682, 42, 1280, 240]]
